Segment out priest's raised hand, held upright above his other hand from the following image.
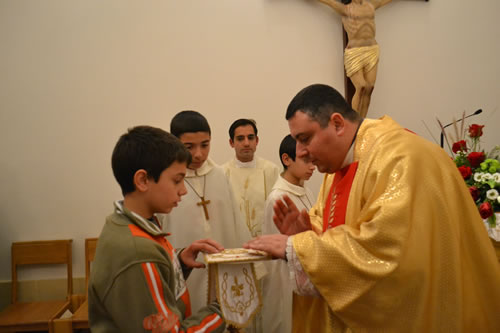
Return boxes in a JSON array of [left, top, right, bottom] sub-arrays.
[[273, 194, 312, 236]]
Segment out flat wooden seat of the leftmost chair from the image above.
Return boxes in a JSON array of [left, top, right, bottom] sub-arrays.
[[0, 300, 70, 330]]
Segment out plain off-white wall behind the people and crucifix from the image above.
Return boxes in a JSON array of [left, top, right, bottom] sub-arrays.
[[0, 0, 500, 280]]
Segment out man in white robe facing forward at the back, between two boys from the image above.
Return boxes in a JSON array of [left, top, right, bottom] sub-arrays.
[[222, 119, 279, 237]]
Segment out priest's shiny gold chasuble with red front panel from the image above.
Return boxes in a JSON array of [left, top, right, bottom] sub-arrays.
[[293, 116, 500, 333]]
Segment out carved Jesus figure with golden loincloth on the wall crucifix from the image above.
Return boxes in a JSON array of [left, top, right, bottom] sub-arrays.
[[319, 0, 392, 117]]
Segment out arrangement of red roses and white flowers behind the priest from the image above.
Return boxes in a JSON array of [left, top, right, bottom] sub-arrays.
[[446, 118, 500, 228]]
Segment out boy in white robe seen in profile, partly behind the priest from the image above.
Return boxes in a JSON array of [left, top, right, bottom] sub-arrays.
[[262, 135, 315, 333]]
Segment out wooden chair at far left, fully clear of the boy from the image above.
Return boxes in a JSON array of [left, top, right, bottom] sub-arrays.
[[0, 239, 73, 332]]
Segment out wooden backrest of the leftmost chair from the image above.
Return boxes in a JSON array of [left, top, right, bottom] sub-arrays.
[[11, 239, 73, 304]]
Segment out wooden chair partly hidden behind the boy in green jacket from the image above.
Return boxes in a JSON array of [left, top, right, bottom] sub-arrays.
[[53, 238, 97, 333]]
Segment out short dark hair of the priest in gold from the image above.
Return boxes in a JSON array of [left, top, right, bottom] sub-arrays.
[[286, 84, 361, 128]]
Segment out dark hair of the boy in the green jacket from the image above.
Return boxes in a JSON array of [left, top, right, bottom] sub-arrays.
[[111, 126, 191, 196]]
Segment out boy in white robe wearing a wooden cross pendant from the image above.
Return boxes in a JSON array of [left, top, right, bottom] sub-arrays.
[[161, 111, 250, 312]]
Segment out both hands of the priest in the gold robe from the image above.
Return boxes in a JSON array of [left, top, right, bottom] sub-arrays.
[[243, 195, 312, 259]]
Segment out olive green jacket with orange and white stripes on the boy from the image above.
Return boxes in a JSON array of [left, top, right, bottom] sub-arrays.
[[88, 202, 225, 333]]
